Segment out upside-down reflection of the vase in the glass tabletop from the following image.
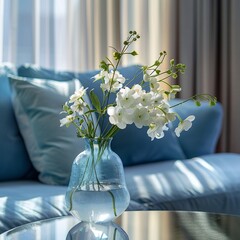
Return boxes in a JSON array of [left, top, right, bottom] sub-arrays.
[[66, 222, 129, 240]]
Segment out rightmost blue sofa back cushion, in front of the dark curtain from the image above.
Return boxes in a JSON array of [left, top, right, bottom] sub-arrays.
[[171, 99, 223, 158]]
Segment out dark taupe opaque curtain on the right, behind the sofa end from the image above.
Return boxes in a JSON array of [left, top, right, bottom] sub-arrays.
[[165, 0, 240, 153]]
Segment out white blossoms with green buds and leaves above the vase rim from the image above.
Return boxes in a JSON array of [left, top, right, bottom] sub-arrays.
[[60, 31, 216, 140]]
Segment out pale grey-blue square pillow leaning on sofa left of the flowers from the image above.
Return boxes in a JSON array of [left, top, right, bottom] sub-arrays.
[[9, 76, 90, 185]]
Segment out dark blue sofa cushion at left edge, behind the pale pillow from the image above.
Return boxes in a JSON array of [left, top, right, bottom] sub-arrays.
[[0, 64, 33, 181]]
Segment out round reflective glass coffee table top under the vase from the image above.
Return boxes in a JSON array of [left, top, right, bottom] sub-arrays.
[[0, 211, 240, 240]]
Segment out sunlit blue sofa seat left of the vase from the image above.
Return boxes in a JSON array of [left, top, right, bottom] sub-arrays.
[[0, 181, 146, 234]]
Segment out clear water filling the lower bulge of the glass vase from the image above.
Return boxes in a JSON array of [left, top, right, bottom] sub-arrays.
[[66, 184, 129, 222]]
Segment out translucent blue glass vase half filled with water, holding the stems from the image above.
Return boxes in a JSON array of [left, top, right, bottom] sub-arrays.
[[65, 139, 130, 223]]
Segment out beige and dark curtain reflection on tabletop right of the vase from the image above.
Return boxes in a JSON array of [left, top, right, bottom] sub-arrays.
[[117, 211, 240, 240]]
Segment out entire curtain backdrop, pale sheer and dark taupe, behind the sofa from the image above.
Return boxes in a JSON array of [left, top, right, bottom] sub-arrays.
[[0, 0, 240, 152]]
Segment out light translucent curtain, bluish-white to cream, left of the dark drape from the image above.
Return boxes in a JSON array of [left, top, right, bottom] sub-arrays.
[[0, 0, 169, 71]]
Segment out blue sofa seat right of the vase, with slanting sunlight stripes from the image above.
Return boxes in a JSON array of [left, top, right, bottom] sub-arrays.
[[125, 153, 240, 215]]
